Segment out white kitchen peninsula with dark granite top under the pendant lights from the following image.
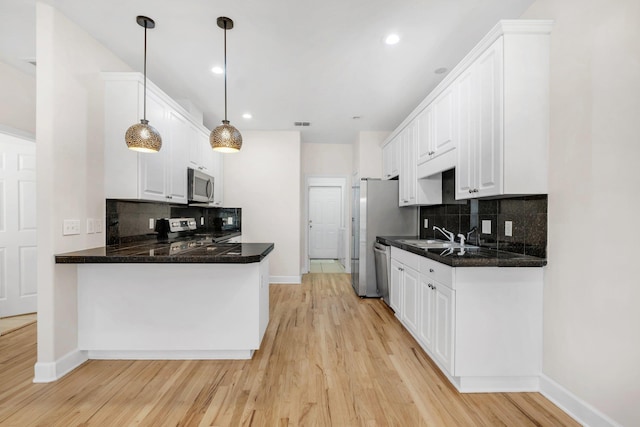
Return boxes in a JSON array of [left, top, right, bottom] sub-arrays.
[[56, 241, 274, 359]]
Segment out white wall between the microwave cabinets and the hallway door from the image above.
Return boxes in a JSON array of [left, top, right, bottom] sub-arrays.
[[224, 130, 301, 283]]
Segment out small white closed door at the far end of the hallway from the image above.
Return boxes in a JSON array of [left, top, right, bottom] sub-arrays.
[[309, 187, 342, 259]]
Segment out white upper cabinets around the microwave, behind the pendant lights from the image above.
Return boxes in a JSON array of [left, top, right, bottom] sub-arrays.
[[102, 73, 222, 205]]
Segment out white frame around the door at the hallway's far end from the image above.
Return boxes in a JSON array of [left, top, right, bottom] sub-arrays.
[[302, 175, 351, 274]]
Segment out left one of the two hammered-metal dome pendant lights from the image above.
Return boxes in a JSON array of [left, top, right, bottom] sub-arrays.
[[124, 16, 162, 153]]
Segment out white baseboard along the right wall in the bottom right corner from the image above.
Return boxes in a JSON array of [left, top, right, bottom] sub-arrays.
[[540, 374, 622, 427]]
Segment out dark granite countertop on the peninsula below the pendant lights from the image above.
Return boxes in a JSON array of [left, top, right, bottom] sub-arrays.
[[56, 237, 274, 264]]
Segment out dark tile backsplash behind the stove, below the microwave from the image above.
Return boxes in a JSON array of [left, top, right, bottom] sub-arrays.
[[106, 199, 242, 245]]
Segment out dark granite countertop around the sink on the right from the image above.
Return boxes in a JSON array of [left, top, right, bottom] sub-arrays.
[[377, 236, 547, 267]]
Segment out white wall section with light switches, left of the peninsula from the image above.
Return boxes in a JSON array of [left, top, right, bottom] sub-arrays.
[[35, 2, 130, 381]]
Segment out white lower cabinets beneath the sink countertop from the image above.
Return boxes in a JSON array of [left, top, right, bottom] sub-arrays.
[[391, 247, 542, 392]]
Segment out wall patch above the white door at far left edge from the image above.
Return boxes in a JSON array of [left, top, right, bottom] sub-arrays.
[[0, 62, 36, 135]]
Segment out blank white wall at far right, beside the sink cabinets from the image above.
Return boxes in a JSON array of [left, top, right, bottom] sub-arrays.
[[523, 0, 640, 426]]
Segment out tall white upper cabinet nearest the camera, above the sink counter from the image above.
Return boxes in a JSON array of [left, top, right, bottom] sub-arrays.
[[456, 21, 551, 199]]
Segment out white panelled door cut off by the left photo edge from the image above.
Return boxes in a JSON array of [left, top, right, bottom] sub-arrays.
[[0, 133, 37, 317]]
